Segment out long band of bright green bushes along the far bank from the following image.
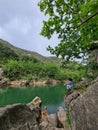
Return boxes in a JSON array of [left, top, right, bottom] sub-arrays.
[[3, 60, 86, 81]]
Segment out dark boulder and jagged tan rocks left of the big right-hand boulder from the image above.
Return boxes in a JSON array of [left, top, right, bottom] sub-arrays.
[[0, 97, 70, 130]]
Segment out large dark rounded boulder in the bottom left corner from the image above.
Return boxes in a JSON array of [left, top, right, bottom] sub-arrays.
[[0, 97, 40, 130]]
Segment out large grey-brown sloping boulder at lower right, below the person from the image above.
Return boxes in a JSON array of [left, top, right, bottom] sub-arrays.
[[65, 82, 98, 130]]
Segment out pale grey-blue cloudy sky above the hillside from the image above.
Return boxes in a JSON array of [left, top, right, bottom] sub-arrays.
[[0, 0, 58, 56]]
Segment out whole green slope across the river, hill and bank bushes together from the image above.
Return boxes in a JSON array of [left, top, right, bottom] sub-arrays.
[[0, 40, 86, 81]]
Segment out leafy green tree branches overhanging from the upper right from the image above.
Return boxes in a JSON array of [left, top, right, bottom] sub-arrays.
[[38, 0, 98, 60]]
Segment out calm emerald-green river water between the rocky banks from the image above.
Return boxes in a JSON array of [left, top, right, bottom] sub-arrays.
[[0, 85, 66, 113]]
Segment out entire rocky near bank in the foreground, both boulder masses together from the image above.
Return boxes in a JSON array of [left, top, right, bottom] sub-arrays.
[[0, 78, 98, 130]]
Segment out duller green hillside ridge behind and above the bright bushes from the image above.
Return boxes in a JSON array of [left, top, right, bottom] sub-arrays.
[[0, 39, 60, 63]]
